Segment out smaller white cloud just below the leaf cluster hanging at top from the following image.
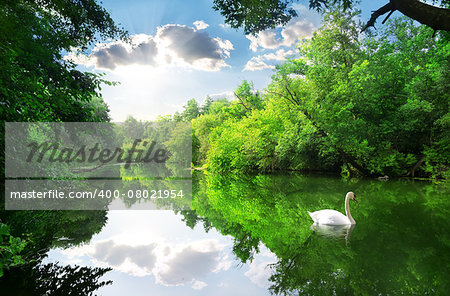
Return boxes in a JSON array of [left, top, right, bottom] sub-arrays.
[[247, 4, 320, 52]]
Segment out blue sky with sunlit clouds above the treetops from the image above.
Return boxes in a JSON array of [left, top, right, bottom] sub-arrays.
[[66, 0, 392, 122]]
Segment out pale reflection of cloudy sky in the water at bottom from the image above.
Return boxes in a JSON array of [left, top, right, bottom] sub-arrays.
[[45, 210, 276, 296]]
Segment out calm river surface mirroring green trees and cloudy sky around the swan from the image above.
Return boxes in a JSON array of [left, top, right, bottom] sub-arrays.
[[1, 174, 450, 295]]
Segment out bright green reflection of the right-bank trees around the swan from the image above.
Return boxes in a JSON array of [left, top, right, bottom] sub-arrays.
[[182, 175, 450, 295]]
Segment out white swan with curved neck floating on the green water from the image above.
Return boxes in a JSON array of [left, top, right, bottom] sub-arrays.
[[308, 192, 357, 225]]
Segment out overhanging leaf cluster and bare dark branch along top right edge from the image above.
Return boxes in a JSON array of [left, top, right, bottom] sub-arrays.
[[213, 0, 450, 34]]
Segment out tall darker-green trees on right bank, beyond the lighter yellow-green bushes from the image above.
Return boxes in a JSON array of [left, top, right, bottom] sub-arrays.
[[269, 11, 449, 177]]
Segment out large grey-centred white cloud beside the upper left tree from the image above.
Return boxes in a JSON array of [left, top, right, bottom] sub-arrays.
[[65, 21, 234, 71]]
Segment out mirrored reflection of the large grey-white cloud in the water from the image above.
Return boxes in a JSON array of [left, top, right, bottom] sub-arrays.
[[61, 239, 232, 290]]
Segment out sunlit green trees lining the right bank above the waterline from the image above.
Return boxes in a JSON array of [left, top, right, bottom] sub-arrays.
[[120, 9, 450, 179]]
